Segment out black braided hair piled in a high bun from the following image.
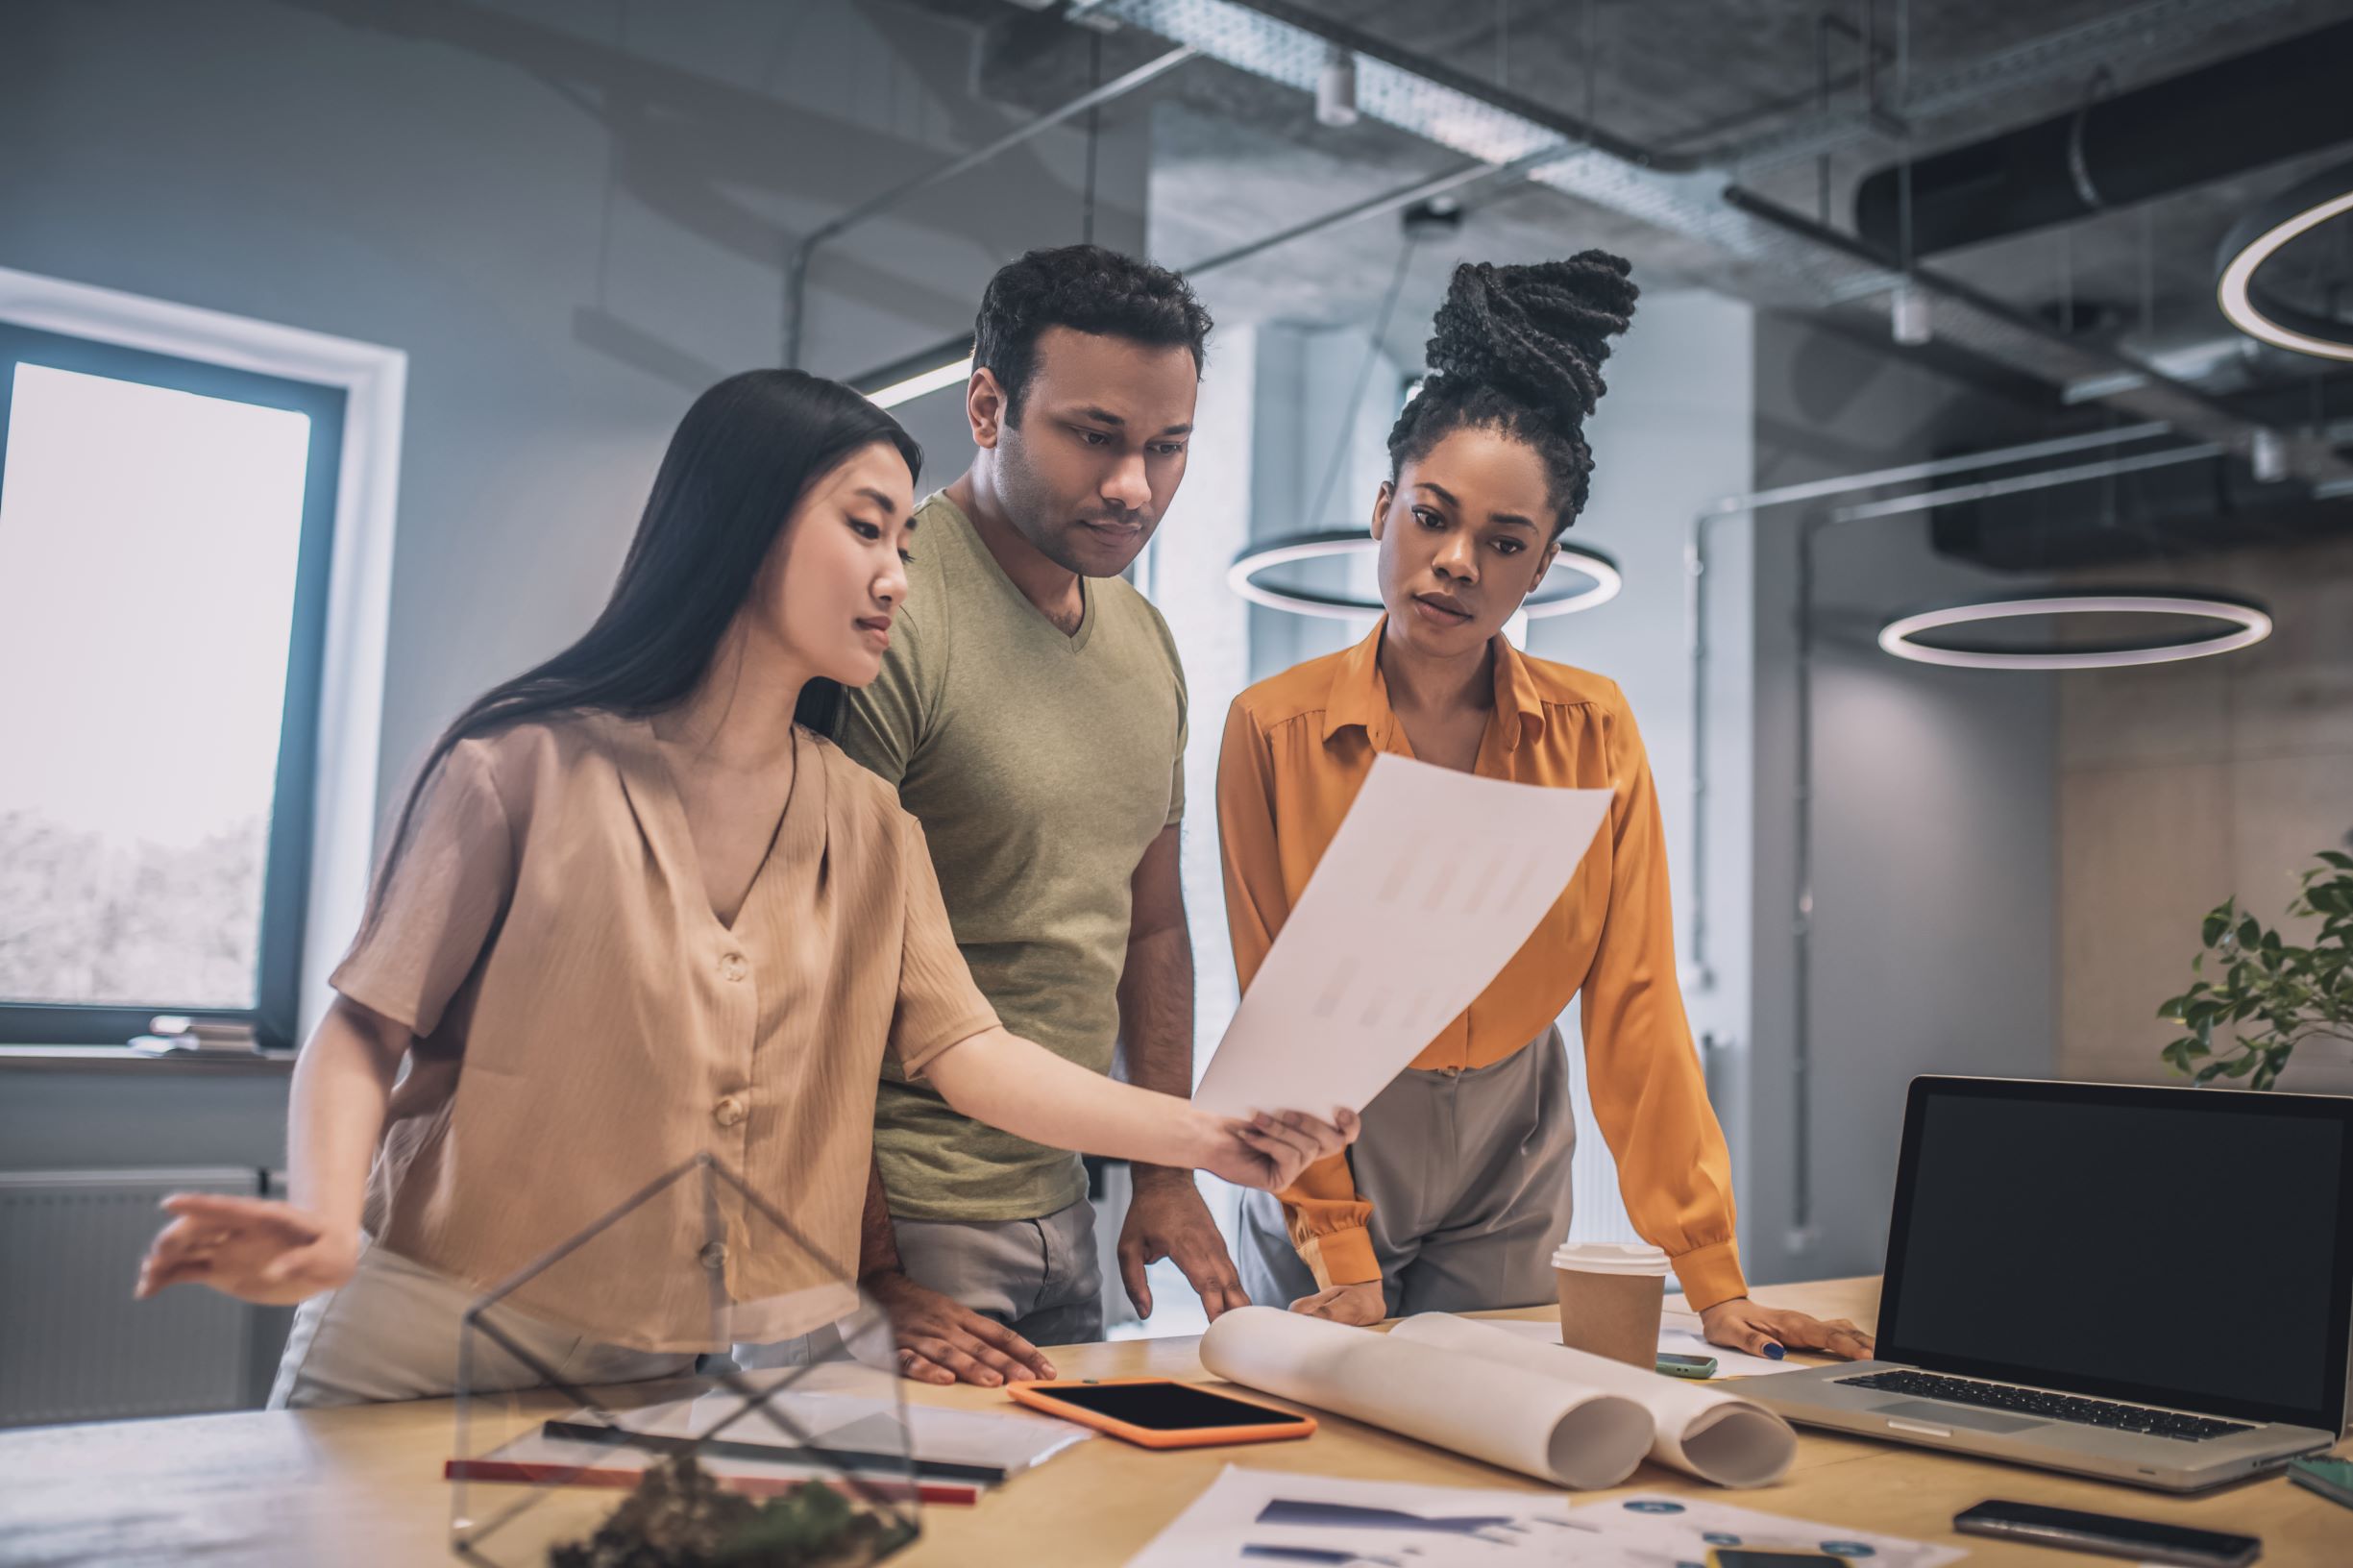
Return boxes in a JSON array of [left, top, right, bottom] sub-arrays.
[[1388, 250, 1640, 539]]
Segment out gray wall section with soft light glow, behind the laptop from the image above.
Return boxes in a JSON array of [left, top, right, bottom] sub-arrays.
[[1744, 318, 2056, 1281]]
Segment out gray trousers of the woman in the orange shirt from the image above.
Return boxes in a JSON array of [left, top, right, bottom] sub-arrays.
[[1236, 1026, 1577, 1318]]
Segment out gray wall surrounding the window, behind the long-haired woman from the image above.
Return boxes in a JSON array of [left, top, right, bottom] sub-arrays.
[[0, 0, 1148, 1187]]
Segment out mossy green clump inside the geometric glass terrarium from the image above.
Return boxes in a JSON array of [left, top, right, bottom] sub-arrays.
[[549, 1455, 916, 1568]]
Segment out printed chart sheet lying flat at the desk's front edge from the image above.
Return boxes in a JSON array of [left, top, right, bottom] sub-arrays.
[[1130, 1467, 1962, 1568]]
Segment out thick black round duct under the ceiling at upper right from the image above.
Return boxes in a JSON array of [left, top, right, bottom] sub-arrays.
[[1854, 21, 2353, 257]]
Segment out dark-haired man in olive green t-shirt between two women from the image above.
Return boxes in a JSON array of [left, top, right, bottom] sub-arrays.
[[840, 245, 1247, 1384]]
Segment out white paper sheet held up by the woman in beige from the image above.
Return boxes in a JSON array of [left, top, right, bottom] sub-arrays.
[[1193, 753, 1609, 1116]]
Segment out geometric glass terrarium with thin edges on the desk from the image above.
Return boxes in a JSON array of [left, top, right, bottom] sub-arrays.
[[445, 1154, 922, 1568]]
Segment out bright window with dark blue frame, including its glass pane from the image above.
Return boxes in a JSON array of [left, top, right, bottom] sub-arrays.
[[0, 323, 346, 1045]]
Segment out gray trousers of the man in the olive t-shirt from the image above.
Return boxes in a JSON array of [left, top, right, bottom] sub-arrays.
[[892, 1198, 1104, 1344]]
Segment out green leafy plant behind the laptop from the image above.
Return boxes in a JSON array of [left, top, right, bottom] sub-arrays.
[[2158, 850, 2353, 1088]]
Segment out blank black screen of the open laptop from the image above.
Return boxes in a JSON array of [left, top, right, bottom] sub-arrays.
[[1877, 1078, 2353, 1429]]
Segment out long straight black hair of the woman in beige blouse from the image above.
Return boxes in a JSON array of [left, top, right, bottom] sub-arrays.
[[362, 370, 922, 930]]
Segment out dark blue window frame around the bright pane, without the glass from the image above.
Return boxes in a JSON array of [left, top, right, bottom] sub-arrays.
[[0, 320, 351, 1047]]
